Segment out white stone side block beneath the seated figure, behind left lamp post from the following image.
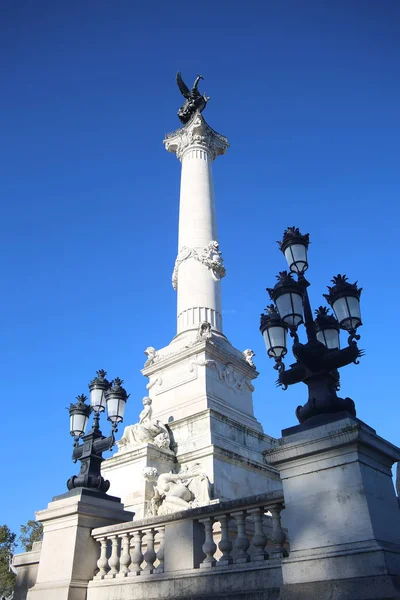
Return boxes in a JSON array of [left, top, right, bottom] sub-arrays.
[[102, 443, 176, 519]]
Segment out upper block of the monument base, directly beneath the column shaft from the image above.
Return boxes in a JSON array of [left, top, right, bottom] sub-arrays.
[[142, 332, 262, 432]]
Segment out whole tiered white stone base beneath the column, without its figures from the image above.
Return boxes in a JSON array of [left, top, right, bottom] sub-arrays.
[[102, 332, 281, 508]]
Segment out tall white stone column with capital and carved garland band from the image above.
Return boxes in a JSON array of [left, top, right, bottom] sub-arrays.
[[164, 112, 229, 334]]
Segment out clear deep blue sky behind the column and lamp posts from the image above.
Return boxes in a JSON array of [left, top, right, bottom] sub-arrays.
[[0, 0, 400, 530]]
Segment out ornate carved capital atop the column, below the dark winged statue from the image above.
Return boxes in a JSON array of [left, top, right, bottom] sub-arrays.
[[164, 112, 229, 160]]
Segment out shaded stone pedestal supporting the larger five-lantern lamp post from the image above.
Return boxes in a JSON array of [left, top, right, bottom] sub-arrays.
[[265, 418, 400, 600]]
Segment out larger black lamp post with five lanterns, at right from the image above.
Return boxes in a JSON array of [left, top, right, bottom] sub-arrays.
[[260, 227, 363, 427]]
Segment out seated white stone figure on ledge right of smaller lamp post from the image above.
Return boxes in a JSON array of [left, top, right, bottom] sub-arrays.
[[117, 397, 170, 450]]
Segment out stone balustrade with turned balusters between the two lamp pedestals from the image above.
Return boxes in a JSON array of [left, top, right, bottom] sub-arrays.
[[92, 492, 288, 581]]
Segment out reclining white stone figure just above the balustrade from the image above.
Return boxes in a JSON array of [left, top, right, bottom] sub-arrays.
[[143, 463, 211, 516]]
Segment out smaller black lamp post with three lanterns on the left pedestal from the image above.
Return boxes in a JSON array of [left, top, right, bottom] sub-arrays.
[[67, 370, 129, 493]]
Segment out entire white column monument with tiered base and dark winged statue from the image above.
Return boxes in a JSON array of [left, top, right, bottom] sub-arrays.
[[103, 73, 281, 517]]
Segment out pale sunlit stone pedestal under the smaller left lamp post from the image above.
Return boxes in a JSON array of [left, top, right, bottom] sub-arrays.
[[27, 488, 134, 600]]
